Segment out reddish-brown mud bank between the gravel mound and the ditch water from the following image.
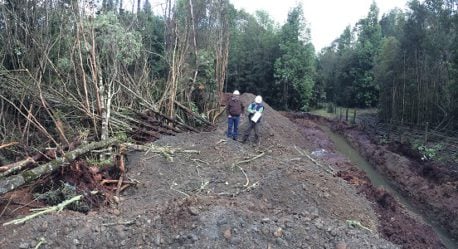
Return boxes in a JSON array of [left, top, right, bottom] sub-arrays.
[[286, 114, 453, 248]]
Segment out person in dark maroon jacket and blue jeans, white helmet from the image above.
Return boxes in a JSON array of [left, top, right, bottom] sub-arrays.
[[226, 90, 245, 140]]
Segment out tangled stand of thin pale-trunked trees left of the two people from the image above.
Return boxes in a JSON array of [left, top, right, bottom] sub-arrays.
[[0, 0, 236, 156]]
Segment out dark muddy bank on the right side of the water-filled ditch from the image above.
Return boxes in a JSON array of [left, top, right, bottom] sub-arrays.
[[334, 120, 458, 242]]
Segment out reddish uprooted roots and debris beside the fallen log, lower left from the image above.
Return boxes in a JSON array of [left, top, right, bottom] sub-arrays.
[[0, 159, 132, 224]]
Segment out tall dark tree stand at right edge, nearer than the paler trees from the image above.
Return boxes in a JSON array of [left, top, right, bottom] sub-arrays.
[[377, 0, 458, 126]]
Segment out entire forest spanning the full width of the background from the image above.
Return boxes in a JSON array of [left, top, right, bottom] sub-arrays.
[[0, 0, 458, 159]]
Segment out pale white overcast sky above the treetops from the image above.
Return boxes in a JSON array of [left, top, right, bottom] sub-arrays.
[[230, 0, 407, 52]]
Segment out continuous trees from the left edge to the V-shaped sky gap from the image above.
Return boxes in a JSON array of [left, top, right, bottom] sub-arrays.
[[0, 0, 316, 159]]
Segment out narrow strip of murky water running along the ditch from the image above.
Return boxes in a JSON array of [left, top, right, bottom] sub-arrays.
[[320, 126, 458, 249]]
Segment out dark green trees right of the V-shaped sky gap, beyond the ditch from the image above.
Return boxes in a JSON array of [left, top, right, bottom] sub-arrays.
[[315, 0, 458, 130]]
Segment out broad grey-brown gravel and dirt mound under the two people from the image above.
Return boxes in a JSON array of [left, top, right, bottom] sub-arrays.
[[0, 94, 450, 249]]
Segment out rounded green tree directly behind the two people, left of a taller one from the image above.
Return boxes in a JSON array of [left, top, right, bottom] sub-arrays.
[[227, 10, 279, 106]]
